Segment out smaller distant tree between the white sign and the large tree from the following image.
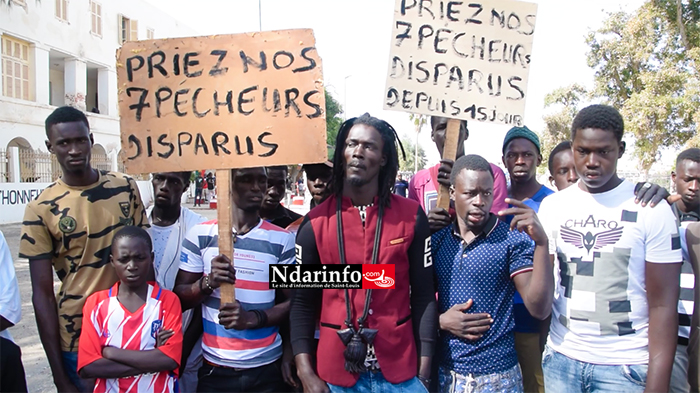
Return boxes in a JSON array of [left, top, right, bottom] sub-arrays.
[[538, 84, 588, 173]]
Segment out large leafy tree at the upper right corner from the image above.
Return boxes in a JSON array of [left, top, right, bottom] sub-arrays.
[[586, 0, 700, 173]]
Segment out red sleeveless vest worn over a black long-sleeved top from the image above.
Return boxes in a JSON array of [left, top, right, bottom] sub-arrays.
[[309, 195, 420, 387]]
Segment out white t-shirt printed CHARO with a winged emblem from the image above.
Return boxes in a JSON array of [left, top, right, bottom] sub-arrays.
[[538, 181, 682, 365]]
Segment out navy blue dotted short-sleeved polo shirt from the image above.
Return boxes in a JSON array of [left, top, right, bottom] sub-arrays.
[[432, 214, 535, 374]]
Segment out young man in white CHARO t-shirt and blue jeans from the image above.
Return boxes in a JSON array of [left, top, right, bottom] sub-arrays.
[[539, 105, 682, 392]]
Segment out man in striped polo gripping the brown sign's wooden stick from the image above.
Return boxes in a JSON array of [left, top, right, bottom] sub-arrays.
[[175, 168, 294, 392]]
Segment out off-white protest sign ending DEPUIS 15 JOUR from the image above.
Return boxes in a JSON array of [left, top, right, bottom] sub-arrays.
[[384, 0, 537, 125]]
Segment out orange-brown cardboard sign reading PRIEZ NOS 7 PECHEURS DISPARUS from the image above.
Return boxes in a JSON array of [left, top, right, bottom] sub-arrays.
[[117, 29, 327, 173]]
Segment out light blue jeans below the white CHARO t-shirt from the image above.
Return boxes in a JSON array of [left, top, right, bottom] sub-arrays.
[[542, 346, 648, 393]]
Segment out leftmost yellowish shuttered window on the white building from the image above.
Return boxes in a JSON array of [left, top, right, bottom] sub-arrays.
[[2, 36, 29, 100]]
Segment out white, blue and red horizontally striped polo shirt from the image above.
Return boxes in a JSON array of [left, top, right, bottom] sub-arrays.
[[180, 220, 295, 368]]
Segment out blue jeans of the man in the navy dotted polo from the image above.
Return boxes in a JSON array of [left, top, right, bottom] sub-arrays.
[[439, 364, 524, 393]]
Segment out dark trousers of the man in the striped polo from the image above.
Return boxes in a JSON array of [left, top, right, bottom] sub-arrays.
[[197, 360, 289, 393]]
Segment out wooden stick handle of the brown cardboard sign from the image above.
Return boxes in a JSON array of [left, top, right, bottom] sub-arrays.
[[216, 169, 236, 304]]
